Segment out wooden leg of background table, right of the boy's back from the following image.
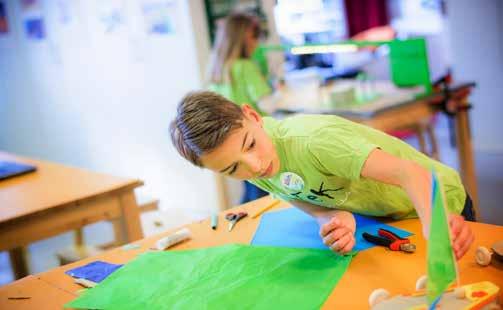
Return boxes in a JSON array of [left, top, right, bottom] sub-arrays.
[[456, 98, 480, 219]]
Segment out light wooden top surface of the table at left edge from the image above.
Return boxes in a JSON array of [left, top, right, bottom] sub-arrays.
[[0, 152, 143, 224]]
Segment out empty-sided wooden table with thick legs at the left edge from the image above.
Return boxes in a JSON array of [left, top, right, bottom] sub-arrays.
[[0, 152, 143, 278]]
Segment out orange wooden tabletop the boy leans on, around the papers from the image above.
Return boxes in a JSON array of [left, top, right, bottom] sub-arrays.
[[2, 197, 503, 309]]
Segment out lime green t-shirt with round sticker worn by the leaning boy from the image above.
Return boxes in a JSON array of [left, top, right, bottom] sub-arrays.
[[250, 115, 466, 219]]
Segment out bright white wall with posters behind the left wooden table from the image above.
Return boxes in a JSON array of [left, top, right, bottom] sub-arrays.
[[0, 0, 217, 218]]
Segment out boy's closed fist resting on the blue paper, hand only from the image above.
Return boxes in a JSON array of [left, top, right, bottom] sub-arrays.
[[320, 217, 355, 254]]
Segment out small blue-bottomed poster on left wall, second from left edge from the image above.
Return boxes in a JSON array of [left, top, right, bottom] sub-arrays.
[[20, 0, 46, 40]]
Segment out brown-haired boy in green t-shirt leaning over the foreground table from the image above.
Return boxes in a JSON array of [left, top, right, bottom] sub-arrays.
[[170, 92, 474, 259]]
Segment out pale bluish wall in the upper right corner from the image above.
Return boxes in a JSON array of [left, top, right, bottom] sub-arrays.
[[447, 0, 503, 153]]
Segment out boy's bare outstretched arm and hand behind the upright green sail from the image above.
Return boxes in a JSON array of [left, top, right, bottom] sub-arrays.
[[361, 149, 474, 259]]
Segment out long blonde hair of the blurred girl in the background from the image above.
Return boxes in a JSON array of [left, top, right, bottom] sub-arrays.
[[208, 13, 260, 84]]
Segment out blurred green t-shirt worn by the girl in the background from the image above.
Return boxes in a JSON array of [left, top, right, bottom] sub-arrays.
[[209, 59, 272, 115]]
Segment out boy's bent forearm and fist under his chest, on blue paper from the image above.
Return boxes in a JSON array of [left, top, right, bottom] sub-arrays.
[[290, 200, 356, 254]]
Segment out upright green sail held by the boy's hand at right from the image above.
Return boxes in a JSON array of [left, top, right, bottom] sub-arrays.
[[427, 174, 457, 305]]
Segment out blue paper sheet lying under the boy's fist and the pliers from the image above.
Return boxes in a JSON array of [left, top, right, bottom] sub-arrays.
[[251, 208, 412, 251]]
